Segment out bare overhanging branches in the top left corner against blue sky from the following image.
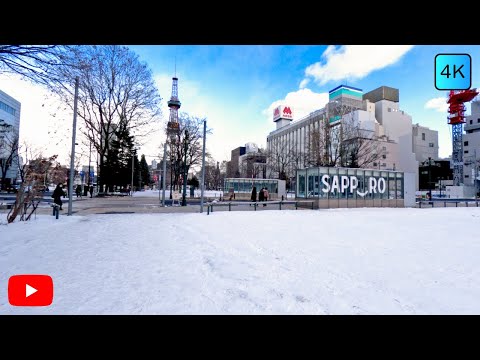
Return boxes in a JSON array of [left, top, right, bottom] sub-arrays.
[[0, 45, 69, 86]]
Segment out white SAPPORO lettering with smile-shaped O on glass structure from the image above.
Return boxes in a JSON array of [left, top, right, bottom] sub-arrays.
[[322, 175, 387, 197]]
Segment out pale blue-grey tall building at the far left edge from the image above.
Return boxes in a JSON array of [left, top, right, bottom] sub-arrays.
[[0, 90, 21, 185]]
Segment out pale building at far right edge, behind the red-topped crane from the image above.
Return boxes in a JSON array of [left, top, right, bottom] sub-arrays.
[[463, 98, 480, 185]]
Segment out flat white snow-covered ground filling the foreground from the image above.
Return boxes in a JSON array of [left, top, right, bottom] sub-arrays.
[[0, 208, 480, 314]]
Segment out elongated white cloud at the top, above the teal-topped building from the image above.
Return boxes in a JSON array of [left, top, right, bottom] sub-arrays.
[[300, 45, 413, 87]]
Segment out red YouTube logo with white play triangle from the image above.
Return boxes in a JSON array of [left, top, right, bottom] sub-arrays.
[[8, 275, 53, 306]]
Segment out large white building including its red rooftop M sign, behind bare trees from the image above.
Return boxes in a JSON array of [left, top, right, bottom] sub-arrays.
[[267, 85, 426, 189]]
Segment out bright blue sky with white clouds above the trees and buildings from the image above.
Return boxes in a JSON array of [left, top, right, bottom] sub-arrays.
[[0, 45, 480, 164]]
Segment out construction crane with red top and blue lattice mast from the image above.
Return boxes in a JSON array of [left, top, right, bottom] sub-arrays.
[[447, 89, 478, 186]]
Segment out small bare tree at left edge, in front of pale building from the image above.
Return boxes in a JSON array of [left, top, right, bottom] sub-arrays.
[[0, 119, 18, 189]]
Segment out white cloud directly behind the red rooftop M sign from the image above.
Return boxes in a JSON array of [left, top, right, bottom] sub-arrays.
[[263, 88, 328, 122]]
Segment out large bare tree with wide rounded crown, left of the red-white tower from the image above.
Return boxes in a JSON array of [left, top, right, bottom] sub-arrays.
[[47, 45, 161, 191]]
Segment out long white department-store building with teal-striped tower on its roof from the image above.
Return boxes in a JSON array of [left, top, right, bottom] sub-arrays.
[[267, 85, 424, 189]]
